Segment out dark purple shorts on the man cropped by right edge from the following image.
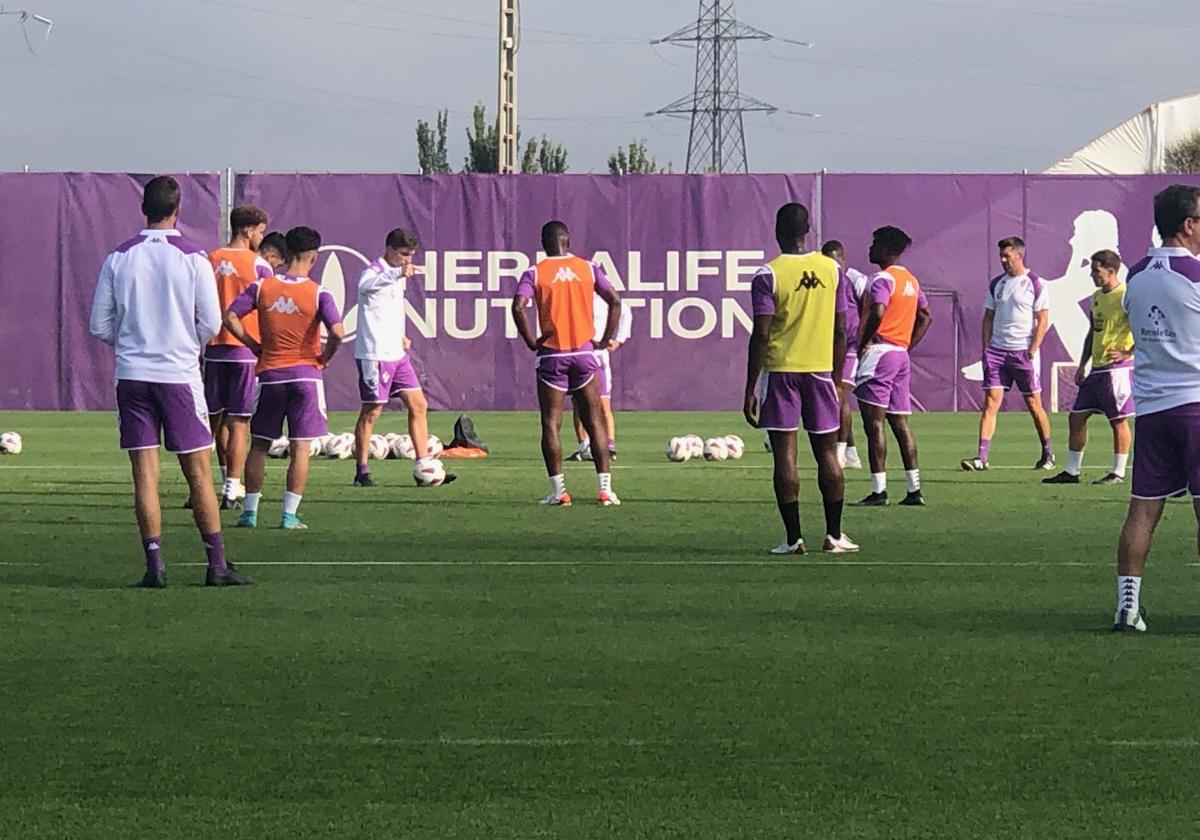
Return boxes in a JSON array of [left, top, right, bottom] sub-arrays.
[[1133, 402, 1200, 499]]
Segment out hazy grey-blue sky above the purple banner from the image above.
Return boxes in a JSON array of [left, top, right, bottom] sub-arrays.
[[0, 0, 1200, 172]]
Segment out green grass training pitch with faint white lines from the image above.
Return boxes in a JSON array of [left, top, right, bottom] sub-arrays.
[[0, 413, 1200, 840]]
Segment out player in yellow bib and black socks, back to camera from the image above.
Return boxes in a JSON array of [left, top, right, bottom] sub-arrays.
[[742, 203, 858, 554]]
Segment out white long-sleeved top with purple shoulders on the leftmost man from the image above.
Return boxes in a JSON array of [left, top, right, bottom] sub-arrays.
[[89, 230, 221, 383]]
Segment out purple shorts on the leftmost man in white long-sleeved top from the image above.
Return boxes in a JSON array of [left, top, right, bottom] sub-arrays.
[[116, 379, 212, 455]]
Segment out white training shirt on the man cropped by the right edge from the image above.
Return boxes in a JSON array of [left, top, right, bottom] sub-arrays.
[[1123, 248, 1200, 416]]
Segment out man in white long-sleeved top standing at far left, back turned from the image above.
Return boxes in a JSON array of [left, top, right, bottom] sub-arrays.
[[89, 175, 250, 589]]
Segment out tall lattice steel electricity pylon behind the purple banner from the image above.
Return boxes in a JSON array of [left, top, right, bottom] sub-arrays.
[[647, 0, 782, 173]]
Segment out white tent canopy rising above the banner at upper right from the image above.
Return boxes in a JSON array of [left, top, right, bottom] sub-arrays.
[[1046, 94, 1200, 175]]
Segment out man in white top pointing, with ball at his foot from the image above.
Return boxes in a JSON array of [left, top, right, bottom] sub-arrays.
[[354, 228, 457, 487]]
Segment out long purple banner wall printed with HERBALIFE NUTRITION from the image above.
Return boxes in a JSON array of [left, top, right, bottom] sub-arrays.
[[0, 173, 1200, 410]]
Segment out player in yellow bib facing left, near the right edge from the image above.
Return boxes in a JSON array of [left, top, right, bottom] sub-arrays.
[[1042, 250, 1134, 485]]
